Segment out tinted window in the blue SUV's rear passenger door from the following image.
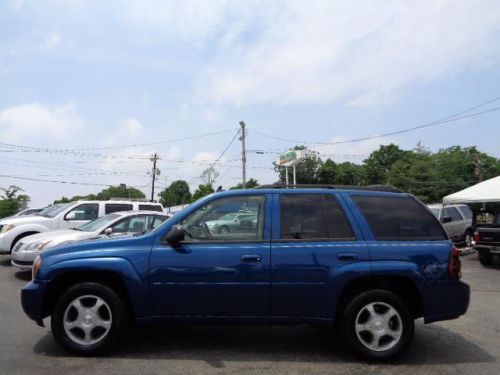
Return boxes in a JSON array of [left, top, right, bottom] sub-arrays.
[[280, 194, 354, 240]]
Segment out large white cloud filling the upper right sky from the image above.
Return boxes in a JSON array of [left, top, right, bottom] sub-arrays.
[[199, 0, 500, 106]]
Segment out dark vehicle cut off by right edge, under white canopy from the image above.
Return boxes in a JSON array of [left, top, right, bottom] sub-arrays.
[[474, 209, 500, 266]]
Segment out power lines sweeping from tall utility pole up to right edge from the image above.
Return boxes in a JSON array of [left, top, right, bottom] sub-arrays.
[[252, 96, 500, 146]]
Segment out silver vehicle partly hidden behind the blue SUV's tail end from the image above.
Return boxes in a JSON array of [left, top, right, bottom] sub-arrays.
[[427, 204, 474, 247]]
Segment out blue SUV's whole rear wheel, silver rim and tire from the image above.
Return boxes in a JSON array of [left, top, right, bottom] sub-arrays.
[[339, 290, 415, 361]]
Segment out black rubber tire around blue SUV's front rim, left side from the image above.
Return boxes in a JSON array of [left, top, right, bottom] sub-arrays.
[[51, 282, 129, 356]]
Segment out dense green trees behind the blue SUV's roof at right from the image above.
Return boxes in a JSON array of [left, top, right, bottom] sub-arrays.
[[275, 143, 500, 203]]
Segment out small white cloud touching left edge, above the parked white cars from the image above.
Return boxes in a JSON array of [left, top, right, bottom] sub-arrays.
[[0, 103, 84, 144]]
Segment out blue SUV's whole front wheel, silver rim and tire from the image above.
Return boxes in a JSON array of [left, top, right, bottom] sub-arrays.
[[51, 282, 127, 355]]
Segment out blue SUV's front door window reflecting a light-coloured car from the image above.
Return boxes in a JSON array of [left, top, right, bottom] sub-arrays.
[[180, 195, 265, 242]]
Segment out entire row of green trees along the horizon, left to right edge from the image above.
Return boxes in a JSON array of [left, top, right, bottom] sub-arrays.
[[0, 143, 500, 218]]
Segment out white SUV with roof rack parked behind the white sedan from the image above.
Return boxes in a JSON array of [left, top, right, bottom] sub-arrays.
[[0, 200, 163, 253]]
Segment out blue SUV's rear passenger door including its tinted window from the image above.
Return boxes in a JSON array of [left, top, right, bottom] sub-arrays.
[[271, 191, 370, 319]]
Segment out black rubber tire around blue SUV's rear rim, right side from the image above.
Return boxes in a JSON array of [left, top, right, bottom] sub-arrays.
[[337, 289, 415, 361]]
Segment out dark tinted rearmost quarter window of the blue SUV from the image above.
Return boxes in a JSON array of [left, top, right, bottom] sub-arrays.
[[351, 195, 447, 241]]
